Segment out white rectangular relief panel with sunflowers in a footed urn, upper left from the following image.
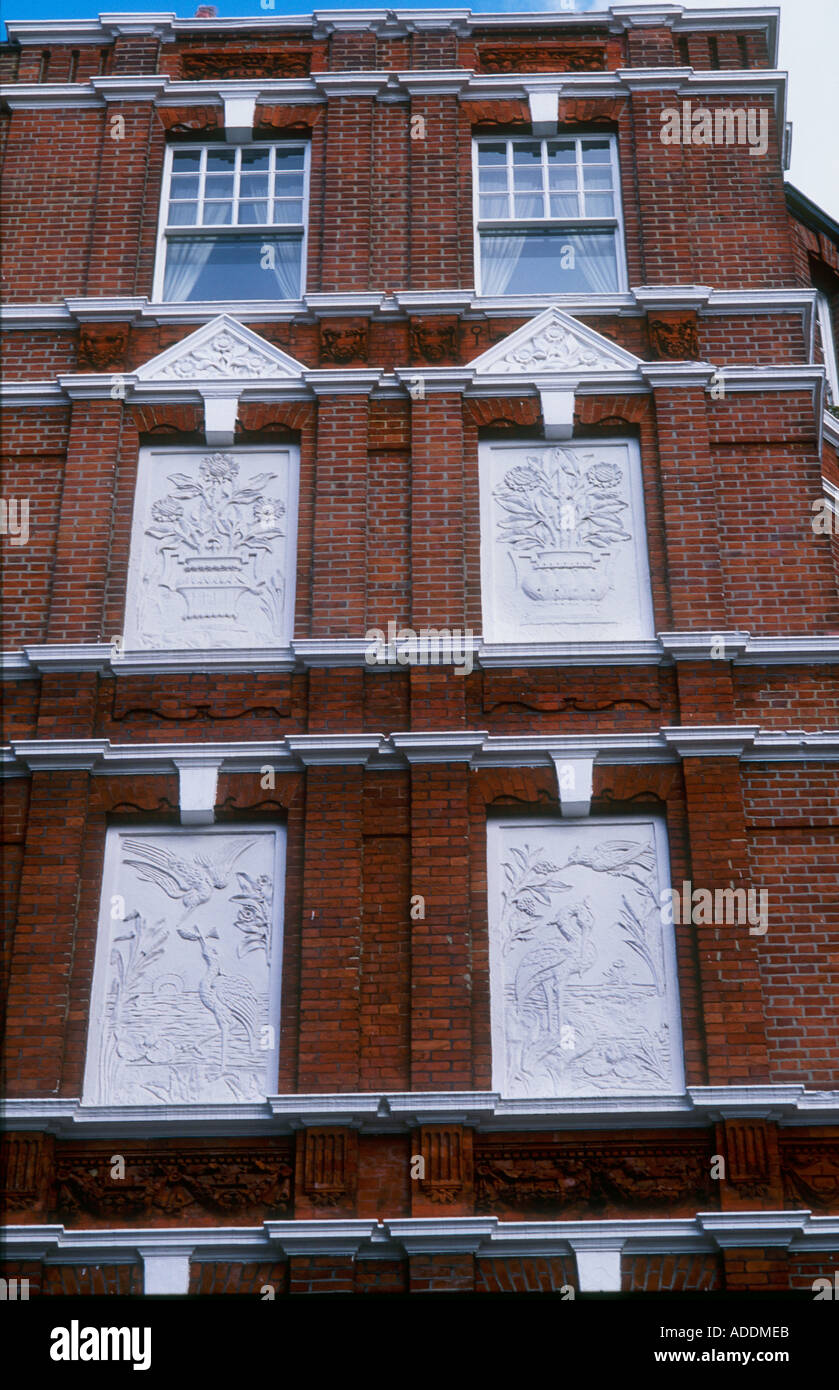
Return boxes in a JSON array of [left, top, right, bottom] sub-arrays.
[[125, 446, 297, 651]]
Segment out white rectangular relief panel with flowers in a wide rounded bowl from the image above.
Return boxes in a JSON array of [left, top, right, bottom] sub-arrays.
[[481, 439, 654, 642]]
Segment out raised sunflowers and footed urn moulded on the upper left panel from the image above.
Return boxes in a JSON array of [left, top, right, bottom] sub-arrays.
[[146, 453, 285, 626]]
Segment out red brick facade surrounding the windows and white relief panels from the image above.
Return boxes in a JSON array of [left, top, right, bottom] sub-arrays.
[[0, 11, 839, 1297]]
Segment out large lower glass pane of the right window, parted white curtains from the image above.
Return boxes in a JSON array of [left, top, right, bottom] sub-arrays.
[[481, 229, 618, 295]]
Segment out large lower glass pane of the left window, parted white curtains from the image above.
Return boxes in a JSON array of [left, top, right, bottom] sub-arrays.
[[163, 234, 301, 303]]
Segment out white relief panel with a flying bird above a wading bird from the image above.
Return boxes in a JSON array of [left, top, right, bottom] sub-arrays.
[[83, 826, 285, 1105]]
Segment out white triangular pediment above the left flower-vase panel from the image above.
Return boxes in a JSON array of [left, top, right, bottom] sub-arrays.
[[136, 314, 308, 382]]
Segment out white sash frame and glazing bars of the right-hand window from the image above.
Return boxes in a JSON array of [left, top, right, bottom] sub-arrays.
[[472, 129, 629, 299]]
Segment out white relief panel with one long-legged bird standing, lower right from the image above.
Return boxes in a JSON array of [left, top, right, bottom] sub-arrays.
[[488, 817, 683, 1098]]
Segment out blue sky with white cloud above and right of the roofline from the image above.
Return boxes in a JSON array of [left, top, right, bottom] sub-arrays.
[[3, 0, 839, 221]]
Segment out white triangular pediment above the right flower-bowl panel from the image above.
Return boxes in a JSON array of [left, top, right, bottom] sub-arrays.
[[470, 304, 640, 377]]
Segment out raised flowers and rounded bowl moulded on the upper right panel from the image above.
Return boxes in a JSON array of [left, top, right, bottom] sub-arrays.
[[495, 449, 632, 602]]
